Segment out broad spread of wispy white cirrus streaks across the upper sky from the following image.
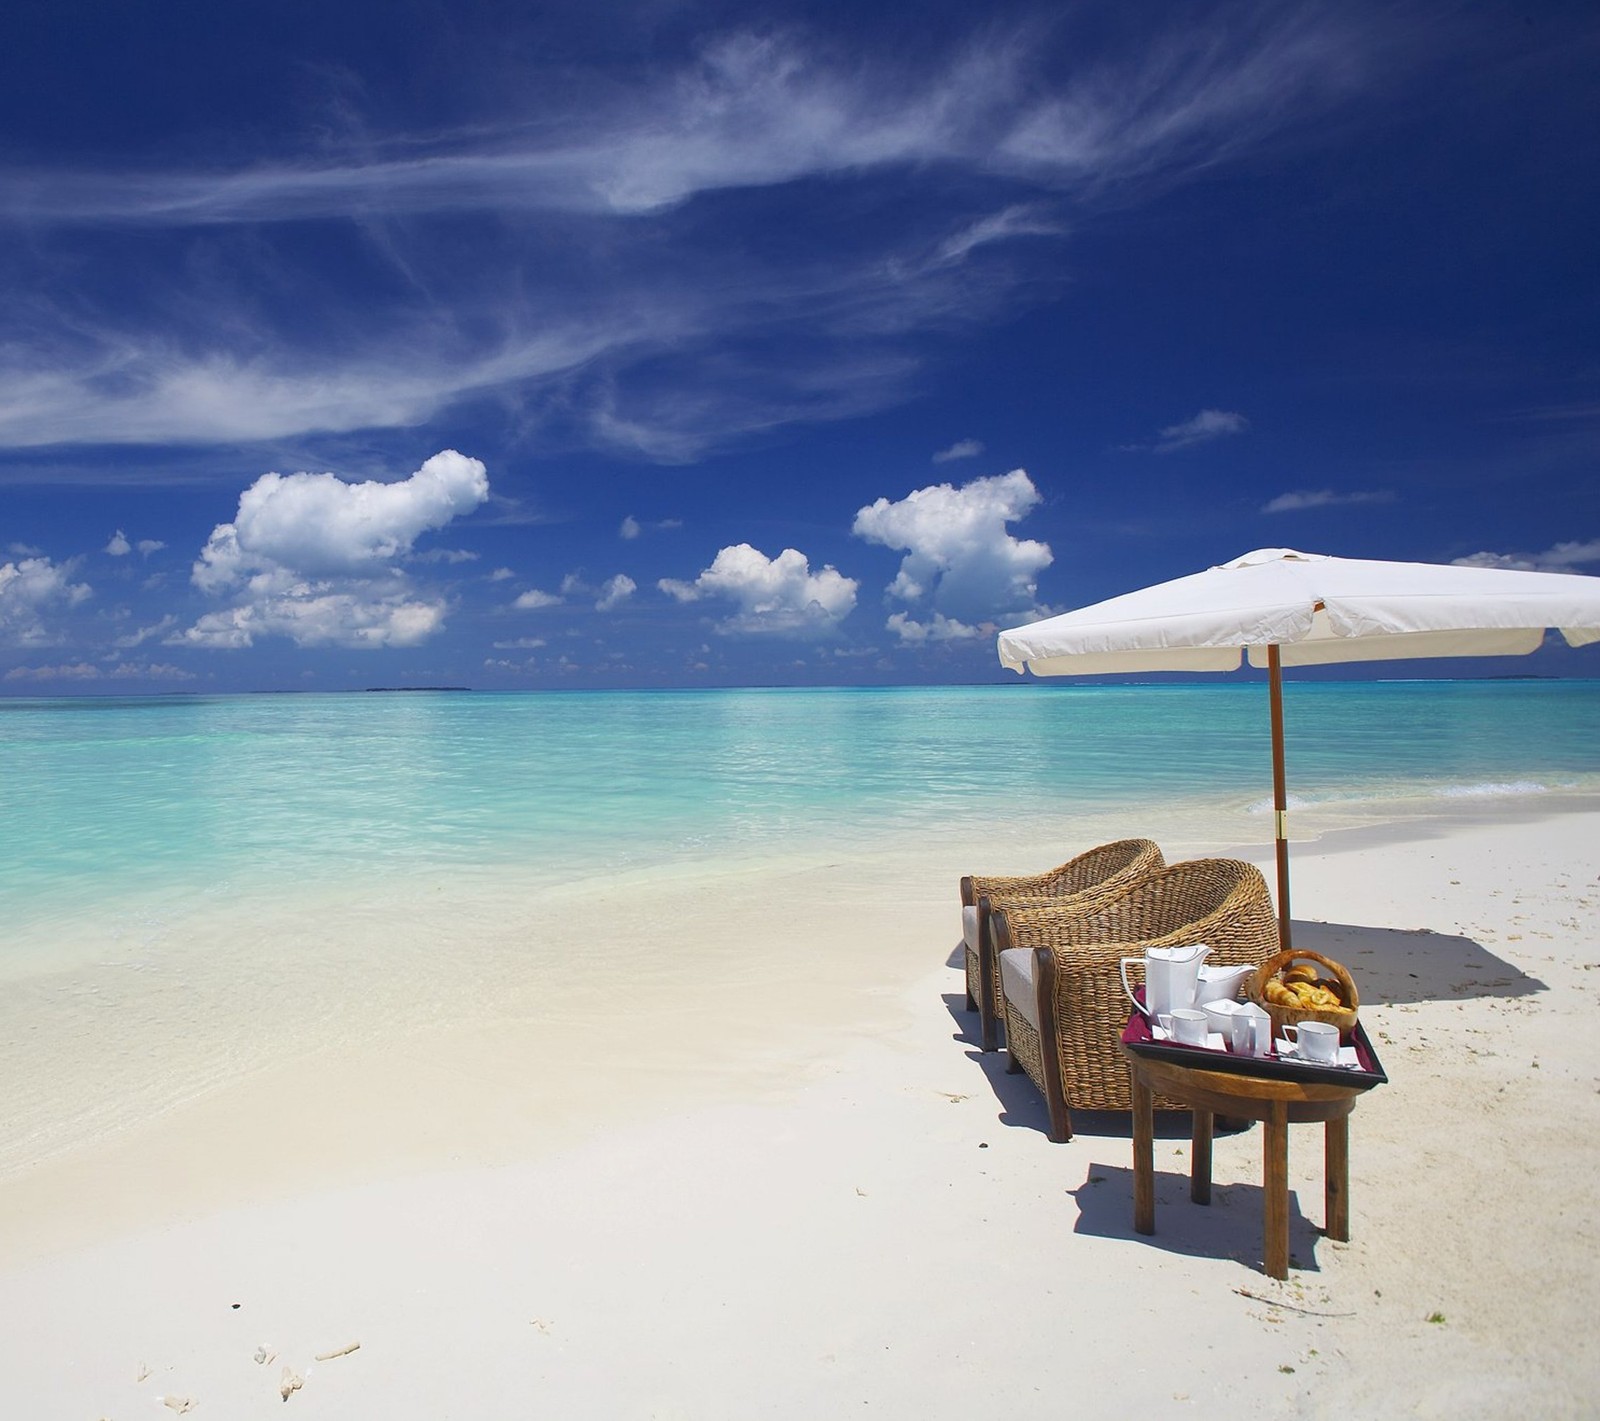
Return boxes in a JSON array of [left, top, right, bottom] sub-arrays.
[[0, 16, 1374, 462]]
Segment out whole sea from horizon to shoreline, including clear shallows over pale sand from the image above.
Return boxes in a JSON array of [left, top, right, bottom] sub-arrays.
[[0, 680, 1600, 1179]]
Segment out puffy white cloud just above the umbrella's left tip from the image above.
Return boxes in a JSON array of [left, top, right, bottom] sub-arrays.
[[853, 469, 1053, 635]]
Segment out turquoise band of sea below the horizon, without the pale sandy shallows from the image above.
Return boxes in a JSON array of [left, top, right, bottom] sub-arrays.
[[0, 680, 1600, 943]]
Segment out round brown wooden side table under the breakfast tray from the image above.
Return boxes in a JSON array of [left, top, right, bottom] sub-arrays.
[[1123, 1043, 1371, 1279]]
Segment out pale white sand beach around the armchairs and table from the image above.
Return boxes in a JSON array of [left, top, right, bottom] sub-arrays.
[[0, 799, 1600, 1421]]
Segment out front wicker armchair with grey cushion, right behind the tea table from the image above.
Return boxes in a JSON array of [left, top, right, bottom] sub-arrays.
[[990, 859, 1278, 1141]]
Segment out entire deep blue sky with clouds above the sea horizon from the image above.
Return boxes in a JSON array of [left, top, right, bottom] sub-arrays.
[[0, 0, 1600, 696]]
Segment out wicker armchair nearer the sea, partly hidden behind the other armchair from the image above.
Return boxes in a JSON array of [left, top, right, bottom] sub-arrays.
[[962, 839, 1163, 1051]]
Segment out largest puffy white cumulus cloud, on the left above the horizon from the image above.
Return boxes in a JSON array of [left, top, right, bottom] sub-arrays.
[[171, 450, 488, 648]]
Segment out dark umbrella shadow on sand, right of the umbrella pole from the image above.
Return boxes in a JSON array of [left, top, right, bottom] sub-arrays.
[[1291, 919, 1549, 1007]]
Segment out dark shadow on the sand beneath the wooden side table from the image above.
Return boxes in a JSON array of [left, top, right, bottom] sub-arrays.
[[1067, 1164, 1325, 1272]]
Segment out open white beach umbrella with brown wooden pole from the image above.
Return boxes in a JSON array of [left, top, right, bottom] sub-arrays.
[[998, 547, 1600, 947]]
